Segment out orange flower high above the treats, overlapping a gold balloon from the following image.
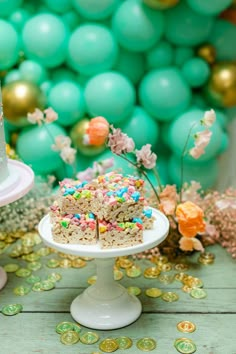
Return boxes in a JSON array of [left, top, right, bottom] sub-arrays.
[[86, 117, 109, 146]]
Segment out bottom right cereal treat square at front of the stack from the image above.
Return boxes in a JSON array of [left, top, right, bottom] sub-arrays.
[[98, 218, 143, 249]]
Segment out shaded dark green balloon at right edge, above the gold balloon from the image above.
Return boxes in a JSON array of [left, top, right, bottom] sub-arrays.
[[208, 19, 236, 61]]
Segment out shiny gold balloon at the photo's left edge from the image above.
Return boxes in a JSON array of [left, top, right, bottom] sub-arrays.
[[2, 81, 46, 127]]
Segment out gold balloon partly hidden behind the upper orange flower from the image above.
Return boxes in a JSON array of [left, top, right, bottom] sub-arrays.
[[70, 118, 106, 156]]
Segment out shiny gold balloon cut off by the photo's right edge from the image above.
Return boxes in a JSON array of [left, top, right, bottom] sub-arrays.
[[204, 62, 236, 108]]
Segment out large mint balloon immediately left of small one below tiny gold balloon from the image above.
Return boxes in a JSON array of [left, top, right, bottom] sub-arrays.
[[139, 67, 191, 121]]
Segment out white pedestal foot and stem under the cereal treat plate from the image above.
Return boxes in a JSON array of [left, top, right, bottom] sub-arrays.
[[70, 258, 142, 330]]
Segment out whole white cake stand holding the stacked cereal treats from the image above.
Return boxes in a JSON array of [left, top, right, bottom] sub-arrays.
[[38, 209, 169, 330]]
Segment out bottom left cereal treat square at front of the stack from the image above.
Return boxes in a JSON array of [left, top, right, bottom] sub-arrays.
[[50, 203, 97, 245]]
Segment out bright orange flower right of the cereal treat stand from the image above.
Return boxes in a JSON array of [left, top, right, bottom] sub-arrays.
[[176, 201, 205, 237]]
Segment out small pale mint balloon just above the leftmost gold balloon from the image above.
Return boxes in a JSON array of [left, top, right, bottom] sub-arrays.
[[19, 60, 48, 85]]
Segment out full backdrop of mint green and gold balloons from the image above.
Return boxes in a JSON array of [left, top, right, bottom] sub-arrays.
[[0, 0, 236, 187]]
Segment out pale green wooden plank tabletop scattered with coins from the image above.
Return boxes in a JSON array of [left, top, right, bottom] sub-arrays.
[[0, 244, 236, 354]]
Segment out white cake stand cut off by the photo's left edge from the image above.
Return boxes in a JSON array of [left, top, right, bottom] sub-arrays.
[[0, 159, 34, 289]]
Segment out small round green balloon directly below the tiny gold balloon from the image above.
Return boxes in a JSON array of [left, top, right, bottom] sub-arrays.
[[181, 57, 210, 88]]
